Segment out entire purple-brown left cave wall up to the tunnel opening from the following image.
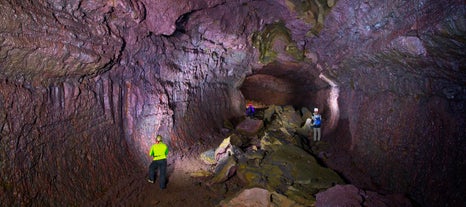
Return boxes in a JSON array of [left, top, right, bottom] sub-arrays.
[[0, 1, 258, 206]]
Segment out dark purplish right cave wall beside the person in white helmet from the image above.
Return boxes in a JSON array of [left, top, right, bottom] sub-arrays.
[[313, 0, 466, 206]]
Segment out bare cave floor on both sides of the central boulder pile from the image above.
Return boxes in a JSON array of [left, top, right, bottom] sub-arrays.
[[89, 139, 382, 207]]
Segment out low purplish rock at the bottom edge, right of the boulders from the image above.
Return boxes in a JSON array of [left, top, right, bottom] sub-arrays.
[[316, 185, 412, 207]]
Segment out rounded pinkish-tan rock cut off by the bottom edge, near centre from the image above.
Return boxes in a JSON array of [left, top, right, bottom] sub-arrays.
[[220, 188, 303, 207]]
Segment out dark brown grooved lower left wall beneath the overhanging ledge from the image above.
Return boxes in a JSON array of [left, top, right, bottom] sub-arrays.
[[0, 77, 140, 206]]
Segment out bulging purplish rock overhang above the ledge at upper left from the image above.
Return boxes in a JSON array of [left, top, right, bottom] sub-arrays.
[[0, 1, 123, 81]]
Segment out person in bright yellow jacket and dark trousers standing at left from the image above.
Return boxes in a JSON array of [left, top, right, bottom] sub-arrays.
[[147, 135, 168, 189]]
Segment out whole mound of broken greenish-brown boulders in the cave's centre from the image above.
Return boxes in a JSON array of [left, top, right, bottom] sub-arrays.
[[200, 106, 409, 206]]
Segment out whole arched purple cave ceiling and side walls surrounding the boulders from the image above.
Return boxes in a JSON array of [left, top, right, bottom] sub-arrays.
[[0, 0, 466, 205]]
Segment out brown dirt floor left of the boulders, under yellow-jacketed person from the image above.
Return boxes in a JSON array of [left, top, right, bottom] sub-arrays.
[[91, 144, 241, 207]]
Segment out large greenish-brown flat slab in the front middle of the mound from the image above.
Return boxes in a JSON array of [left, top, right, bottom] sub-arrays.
[[237, 144, 344, 205]]
